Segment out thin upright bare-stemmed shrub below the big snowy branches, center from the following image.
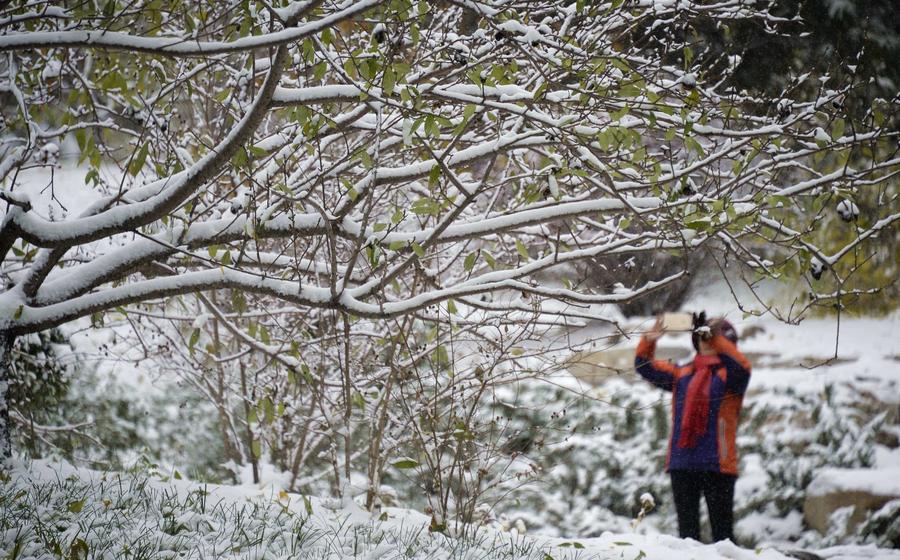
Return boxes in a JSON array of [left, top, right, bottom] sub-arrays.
[[109, 304, 556, 525]]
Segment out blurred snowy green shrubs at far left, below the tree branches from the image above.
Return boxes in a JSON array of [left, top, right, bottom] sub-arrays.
[[11, 349, 227, 474]]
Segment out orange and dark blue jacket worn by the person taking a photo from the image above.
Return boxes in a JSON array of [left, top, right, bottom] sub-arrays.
[[634, 335, 750, 475]]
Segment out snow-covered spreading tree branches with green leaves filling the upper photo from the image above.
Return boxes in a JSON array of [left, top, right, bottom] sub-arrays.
[[0, 0, 900, 482]]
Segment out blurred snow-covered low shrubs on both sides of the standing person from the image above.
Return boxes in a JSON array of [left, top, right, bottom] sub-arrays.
[[482, 360, 900, 547]]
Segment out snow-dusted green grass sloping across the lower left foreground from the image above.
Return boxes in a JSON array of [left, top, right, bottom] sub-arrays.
[[0, 465, 545, 560]]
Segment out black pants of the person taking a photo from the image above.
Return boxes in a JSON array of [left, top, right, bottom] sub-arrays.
[[669, 471, 737, 541]]
